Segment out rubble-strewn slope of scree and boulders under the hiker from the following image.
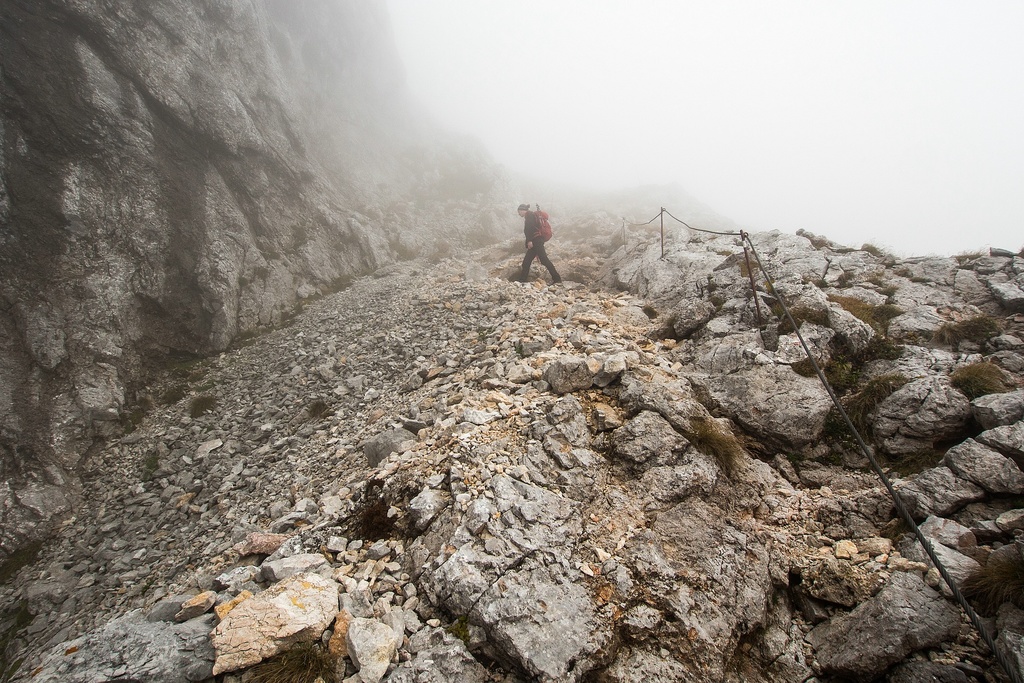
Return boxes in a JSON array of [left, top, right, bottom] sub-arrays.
[[2, 219, 1024, 683]]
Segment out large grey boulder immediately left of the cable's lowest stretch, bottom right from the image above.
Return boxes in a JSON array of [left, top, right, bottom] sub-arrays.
[[807, 571, 959, 679]]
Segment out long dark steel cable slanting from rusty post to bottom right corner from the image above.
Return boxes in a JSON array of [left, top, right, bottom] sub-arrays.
[[741, 231, 1024, 683]]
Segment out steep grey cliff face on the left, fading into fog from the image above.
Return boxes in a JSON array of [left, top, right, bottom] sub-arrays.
[[0, 0, 513, 558]]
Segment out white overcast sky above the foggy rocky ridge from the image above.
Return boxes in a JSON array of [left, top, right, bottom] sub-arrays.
[[388, 0, 1024, 256]]
